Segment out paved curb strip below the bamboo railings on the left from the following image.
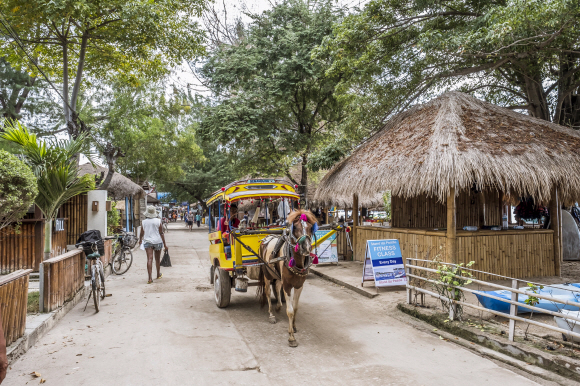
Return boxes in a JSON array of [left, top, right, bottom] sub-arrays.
[[6, 286, 89, 364]]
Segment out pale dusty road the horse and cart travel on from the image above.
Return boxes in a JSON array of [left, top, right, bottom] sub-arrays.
[[5, 222, 548, 386]]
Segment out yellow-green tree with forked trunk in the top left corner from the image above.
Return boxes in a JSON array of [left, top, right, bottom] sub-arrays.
[[0, 0, 204, 138]]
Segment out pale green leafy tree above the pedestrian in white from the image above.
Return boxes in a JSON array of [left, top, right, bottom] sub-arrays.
[[80, 82, 203, 185]]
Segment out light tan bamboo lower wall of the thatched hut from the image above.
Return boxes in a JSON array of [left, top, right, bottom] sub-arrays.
[[355, 227, 556, 280]]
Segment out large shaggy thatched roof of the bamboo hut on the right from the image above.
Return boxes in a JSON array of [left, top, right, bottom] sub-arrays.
[[315, 92, 580, 206]]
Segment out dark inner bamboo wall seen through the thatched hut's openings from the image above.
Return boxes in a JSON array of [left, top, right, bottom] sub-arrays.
[[391, 190, 502, 229]]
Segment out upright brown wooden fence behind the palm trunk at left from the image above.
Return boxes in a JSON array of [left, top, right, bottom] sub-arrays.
[[0, 219, 68, 274]]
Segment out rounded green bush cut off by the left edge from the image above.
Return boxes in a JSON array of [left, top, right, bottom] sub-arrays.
[[0, 150, 38, 229]]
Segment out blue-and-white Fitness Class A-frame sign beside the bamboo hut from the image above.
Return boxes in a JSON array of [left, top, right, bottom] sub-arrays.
[[363, 239, 407, 287]]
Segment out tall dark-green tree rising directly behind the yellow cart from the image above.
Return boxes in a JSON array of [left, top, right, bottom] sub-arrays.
[[200, 0, 344, 198]]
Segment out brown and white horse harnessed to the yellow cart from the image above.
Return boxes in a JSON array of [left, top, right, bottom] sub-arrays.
[[248, 210, 318, 347]]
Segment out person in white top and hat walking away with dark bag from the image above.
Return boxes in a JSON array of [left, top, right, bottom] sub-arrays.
[[139, 205, 168, 284]]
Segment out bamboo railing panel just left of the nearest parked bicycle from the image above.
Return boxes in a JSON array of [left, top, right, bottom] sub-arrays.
[[40, 249, 85, 312]]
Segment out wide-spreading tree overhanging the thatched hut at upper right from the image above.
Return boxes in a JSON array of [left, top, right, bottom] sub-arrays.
[[315, 0, 580, 128]]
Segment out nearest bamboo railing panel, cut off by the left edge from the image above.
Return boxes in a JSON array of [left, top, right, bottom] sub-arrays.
[[0, 269, 32, 345]]
